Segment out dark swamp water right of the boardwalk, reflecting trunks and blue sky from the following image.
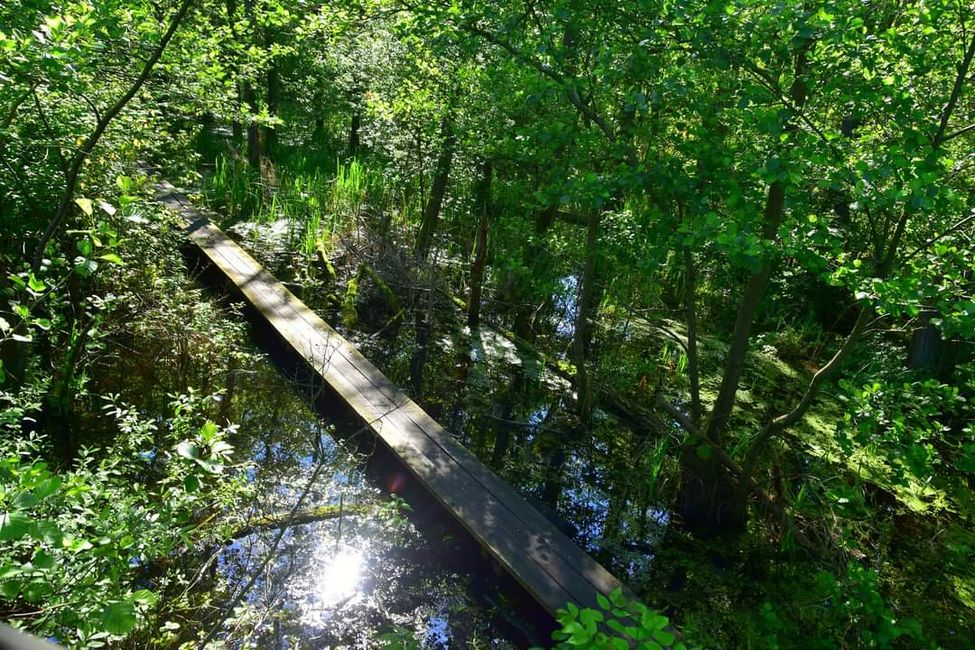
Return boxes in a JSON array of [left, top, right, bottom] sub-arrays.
[[223, 224, 670, 586]]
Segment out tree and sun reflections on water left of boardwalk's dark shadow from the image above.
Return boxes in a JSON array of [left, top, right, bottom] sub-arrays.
[[197, 356, 520, 648]]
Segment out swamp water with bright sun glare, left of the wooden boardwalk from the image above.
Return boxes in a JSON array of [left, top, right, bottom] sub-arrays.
[[93, 268, 551, 649]]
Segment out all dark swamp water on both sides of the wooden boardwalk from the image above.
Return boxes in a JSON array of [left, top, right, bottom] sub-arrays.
[[103, 199, 668, 648]]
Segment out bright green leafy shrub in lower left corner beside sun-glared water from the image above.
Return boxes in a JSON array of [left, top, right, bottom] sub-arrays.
[[0, 394, 242, 648]]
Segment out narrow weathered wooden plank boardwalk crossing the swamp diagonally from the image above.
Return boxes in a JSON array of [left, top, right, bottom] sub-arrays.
[[156, 182, 620, 615]]
